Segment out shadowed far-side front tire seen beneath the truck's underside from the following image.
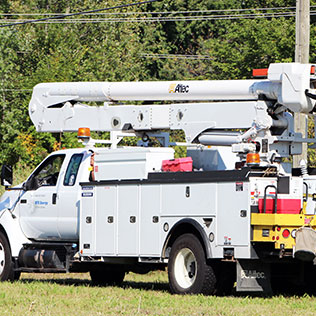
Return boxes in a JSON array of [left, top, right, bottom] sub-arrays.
[[90, 268, 125, 286]]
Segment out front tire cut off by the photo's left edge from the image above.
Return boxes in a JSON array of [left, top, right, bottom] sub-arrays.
[[0, 232, 15, 281]]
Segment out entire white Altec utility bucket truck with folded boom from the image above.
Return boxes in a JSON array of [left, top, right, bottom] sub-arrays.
[[0, 63, 316, 294]]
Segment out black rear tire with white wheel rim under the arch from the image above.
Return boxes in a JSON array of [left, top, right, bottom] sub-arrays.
[[168, 234, 216, 295]]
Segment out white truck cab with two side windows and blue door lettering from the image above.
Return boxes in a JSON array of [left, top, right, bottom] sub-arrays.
[[16, 149, 92, 241]]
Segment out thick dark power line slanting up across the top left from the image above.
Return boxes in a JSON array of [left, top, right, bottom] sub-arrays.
[[0, 0, 160, 27]]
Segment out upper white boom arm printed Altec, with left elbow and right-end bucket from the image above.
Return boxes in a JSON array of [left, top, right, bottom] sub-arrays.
[[29, 63, 316, 128]]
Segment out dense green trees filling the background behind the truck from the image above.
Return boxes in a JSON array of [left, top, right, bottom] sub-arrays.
[[0, 0, 316, 166]]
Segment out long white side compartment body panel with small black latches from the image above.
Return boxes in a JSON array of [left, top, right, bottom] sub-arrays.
[[79, 163, 250, 258]]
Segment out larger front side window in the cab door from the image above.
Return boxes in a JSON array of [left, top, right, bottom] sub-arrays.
[[28, 155, 65, 190]]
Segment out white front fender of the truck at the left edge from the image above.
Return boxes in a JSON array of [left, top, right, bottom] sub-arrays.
[[0, 209, 30, 257]]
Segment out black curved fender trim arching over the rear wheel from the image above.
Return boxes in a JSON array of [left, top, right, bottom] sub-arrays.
[[161, 218, 212, 259]]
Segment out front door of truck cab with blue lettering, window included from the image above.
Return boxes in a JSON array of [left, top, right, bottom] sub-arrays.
[[19, 154, 65, 240]]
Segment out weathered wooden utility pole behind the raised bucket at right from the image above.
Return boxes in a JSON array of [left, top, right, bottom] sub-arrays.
[[293, 0, 310, 168]]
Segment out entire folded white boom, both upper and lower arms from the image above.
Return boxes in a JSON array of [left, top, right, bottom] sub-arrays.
[[29, 63, 316, 160]]
